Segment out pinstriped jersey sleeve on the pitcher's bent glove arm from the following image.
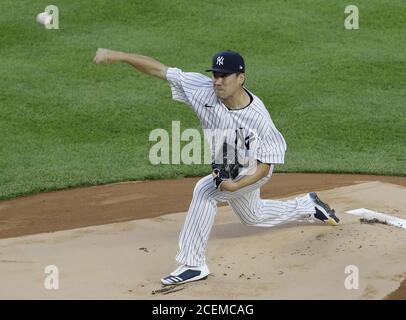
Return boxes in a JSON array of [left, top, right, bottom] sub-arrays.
[[256, 125, 286, 164]]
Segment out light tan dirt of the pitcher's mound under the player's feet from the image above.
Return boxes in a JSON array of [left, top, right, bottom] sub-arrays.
[[0, 181, 406, 299]]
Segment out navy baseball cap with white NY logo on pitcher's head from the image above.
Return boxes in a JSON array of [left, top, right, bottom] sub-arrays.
[[206, 50, 245, 73]]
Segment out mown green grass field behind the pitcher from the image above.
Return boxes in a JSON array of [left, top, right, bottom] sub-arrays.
[[0, 0, 406, 199]]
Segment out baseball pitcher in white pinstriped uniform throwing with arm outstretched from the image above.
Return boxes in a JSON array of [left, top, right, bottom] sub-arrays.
[[93, 49, 339, 285]]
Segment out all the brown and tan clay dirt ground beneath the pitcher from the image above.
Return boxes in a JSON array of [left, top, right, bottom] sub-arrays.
[[0, 173, 406, 299]]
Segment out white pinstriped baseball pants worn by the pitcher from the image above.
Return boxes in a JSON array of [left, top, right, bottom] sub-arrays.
[[176, 166, 315, 266]]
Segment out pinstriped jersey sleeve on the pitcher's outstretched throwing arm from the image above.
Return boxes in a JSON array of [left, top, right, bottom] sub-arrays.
[[166, 68, 212, 105]]
